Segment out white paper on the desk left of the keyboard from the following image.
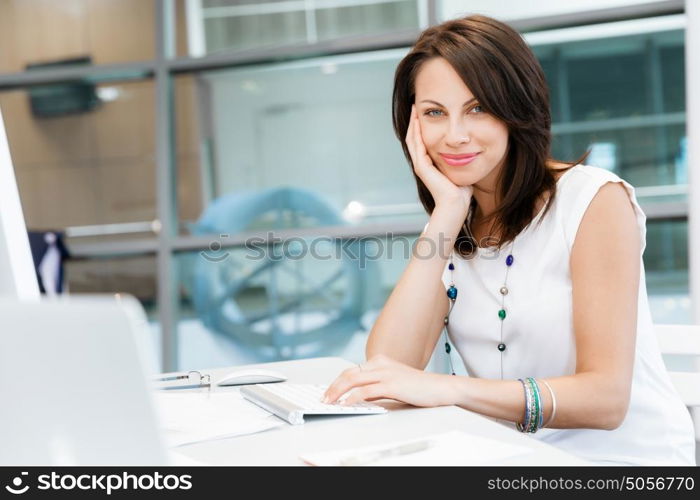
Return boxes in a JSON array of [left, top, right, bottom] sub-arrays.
[[155, 391, 285, 447]]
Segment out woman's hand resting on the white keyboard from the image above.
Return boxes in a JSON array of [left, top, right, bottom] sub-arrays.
[[324, 354, 456, 407]]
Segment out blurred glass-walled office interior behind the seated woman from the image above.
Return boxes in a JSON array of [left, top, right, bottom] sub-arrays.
[[0, 0, 692, 370]]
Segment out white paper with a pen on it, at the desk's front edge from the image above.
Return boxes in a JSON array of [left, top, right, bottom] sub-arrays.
[[300, 431, 533, 466]]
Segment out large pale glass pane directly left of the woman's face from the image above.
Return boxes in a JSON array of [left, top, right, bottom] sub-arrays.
[[176, 50, 425, 233]]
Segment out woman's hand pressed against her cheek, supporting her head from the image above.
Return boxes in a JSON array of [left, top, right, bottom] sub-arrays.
[[406, 104, 474, 215]]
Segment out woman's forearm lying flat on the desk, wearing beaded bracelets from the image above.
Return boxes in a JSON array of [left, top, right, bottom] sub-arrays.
[[444, 373, 629, 430]]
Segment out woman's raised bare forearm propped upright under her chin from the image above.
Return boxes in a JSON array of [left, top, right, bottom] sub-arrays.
[[366, 204, 466, 369]]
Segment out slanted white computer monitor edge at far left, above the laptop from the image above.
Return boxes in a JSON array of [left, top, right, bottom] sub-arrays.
[[0, 106, 40, 300]]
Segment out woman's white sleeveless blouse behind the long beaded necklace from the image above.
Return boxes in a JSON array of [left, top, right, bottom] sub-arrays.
[[442, 165, 695, 465]]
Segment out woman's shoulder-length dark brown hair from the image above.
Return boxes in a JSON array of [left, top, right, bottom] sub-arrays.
[[392, 15, 588, 256]]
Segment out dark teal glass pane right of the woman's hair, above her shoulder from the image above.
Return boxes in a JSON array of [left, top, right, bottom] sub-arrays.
[[535, 30, 687, 191]]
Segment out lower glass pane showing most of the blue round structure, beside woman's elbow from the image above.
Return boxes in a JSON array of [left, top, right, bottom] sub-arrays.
[[178, 232, 416, 366]]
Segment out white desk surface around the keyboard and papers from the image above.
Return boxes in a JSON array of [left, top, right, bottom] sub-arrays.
[[175, 358, 586, 465]]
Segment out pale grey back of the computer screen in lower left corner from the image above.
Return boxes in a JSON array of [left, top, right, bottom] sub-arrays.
[[0, 296, 168, 464]]
